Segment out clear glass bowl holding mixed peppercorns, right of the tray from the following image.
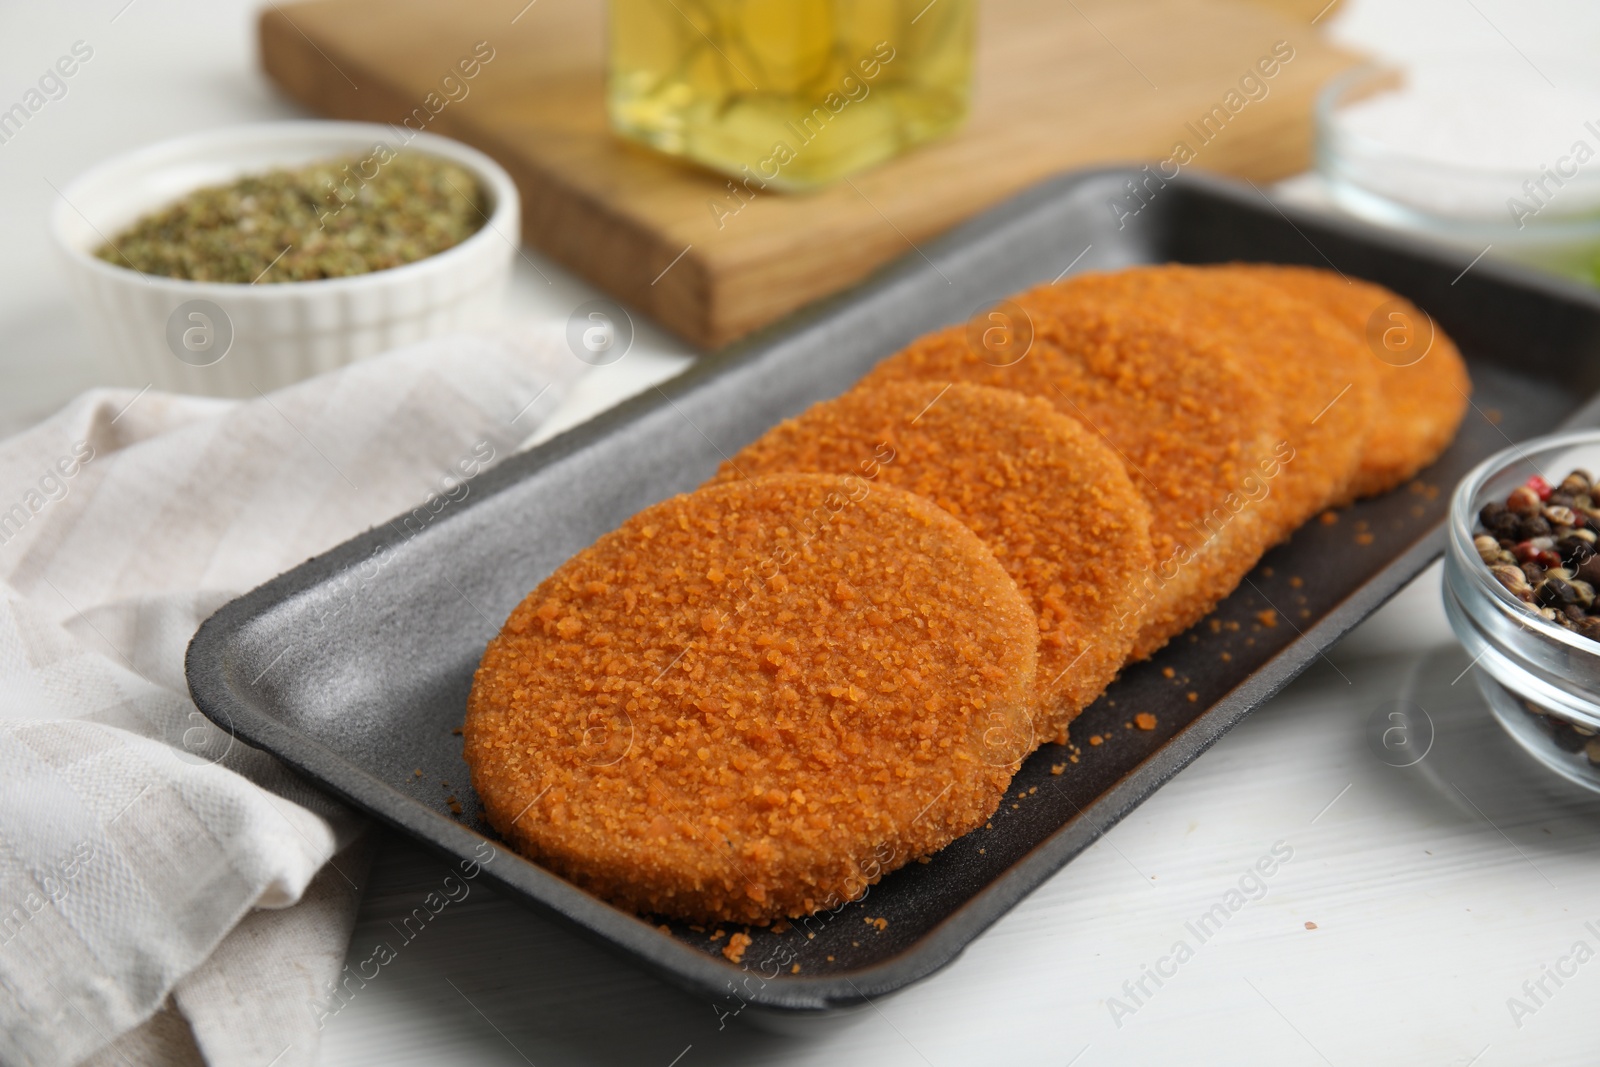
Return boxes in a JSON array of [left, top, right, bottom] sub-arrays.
[[1443, 430, 1600, 792]]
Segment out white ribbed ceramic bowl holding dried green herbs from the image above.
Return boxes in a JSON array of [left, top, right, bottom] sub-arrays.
[[51, 122, 520, 397]]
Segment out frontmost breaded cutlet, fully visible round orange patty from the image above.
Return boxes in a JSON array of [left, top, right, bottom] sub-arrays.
[[462, 474, 1038, 923]]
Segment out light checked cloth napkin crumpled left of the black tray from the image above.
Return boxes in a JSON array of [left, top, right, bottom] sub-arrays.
[[0, 330, 587, 1067]]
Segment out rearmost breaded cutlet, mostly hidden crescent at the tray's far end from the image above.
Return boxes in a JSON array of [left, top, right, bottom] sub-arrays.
[[1218, 264, 1472, 499]]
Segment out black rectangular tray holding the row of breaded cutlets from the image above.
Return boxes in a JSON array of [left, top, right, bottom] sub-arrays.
[[187, 170, 1600, 1013]]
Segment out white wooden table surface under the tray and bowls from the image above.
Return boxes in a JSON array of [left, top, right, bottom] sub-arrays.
[[0, 0, 1600, 1067]]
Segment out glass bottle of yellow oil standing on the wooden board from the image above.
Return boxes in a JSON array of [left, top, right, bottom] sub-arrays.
[[608, 0, 976, 190]]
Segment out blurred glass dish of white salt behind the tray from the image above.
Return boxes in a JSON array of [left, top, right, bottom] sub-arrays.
[[1315, 64, 1600, 282]]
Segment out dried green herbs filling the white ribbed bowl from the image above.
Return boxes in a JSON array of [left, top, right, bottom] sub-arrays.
[[94, 146, 490, 285]]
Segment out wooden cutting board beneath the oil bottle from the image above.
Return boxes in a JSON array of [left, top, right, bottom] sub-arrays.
[[261, 0, 1355, 347]]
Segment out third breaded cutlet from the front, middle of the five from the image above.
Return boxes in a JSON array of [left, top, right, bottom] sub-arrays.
[[859, 298, 1283, 659]]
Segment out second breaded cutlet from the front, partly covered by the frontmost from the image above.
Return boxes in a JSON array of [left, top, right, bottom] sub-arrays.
[[715, 381, 1155, 744]]
